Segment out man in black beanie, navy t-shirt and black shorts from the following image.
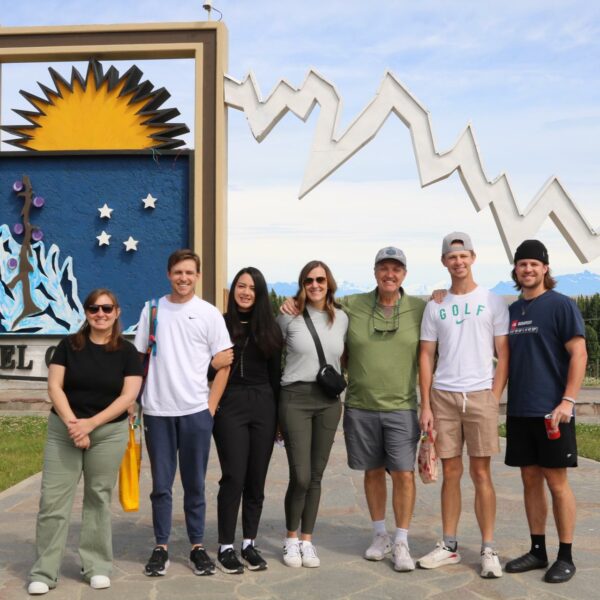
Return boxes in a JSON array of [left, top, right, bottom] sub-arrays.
[[505, 240, 587, 583]]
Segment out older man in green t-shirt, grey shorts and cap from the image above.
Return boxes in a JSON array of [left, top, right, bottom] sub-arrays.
[[282, 246, 425, 571]]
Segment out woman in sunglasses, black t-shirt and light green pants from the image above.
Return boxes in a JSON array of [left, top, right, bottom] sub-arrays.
[[28, 289, 142, 594]]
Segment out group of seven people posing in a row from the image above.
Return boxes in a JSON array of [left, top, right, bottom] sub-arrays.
[[28, 232, 587, 594]]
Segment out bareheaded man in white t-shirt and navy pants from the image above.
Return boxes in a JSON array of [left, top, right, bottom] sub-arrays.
[[135, 250, 232, 577]]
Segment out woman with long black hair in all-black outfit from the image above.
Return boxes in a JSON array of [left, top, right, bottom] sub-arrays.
[[212, 267, 283, 574]]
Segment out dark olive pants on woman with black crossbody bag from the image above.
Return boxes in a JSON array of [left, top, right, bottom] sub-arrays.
[[279, 383, 342, 534]]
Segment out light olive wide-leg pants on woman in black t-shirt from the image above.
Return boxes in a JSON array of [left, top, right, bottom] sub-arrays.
[[29, 413, 128, 588]]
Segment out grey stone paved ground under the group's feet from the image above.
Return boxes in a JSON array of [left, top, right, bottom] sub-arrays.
[[0, 432, 600, 600]]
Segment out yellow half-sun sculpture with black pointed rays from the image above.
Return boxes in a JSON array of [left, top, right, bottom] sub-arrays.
[[2, 60, 189, 151]]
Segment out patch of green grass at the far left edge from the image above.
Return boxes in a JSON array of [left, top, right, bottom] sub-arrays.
[[0, 416, 48, 492]]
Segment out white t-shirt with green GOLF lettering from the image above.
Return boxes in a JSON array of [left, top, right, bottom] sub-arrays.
[[421, 286, 508, 392]]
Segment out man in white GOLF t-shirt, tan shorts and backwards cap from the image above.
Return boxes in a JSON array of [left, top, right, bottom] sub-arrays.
[[417, 231, 508, 578]]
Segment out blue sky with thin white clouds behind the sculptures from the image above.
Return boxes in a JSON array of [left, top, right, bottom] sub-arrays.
[[0, 0, 600, 291]]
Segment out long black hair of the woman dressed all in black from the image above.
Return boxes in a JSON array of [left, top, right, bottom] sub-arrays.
[[225, 267, 283, 358]]
